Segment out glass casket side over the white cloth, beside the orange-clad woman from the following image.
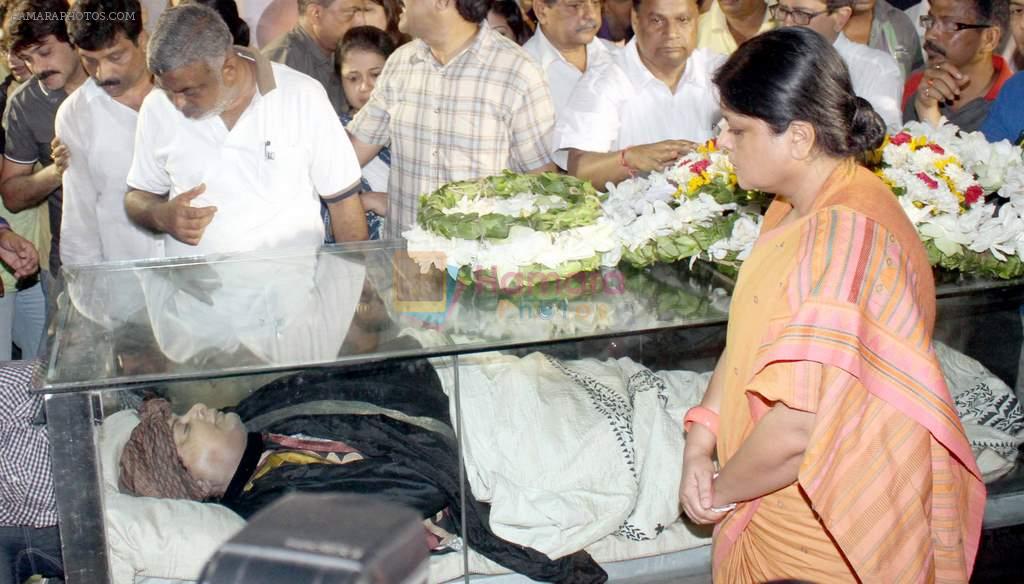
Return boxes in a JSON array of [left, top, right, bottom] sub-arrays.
[[448, 324, 725, 582]]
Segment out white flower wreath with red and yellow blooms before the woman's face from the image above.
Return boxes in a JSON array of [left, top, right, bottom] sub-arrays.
[[604, 140, 766, 267]]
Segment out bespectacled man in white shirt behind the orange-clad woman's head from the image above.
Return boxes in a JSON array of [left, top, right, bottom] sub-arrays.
[[770, 0, 903, 130]]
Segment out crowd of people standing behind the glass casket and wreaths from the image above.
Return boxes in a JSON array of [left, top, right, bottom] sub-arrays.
[[0, 0, 1024, 358]]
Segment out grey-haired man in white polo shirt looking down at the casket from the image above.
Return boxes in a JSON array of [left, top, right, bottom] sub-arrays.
[[125, 4, 367, 256]]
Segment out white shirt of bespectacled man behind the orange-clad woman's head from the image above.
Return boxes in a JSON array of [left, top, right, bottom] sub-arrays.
[[833, 33, 903, 130]]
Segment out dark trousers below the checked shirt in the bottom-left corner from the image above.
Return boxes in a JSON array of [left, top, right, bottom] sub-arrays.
[[0, 527, 63, 584]]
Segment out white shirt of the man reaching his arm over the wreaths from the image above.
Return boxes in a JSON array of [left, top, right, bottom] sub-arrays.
[[552, 39, 725, 152]]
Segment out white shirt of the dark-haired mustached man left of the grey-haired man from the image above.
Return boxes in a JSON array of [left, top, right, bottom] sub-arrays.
[[56, 77, 157, 265]]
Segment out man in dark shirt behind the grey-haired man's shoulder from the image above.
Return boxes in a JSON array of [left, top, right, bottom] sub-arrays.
[[263, 0, 367, 115]]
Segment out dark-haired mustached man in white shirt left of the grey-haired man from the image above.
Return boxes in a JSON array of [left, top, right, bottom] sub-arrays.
[[56, 0, 156, 265]]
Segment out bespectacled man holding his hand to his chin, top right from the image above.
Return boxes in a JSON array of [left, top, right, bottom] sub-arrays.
[[903, 0, 1011, 131]]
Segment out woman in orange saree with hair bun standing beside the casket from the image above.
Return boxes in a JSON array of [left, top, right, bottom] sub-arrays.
[[680, 28, 985, 584]]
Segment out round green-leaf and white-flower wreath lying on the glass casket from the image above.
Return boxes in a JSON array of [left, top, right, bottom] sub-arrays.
[[402, 171, 618, 287]]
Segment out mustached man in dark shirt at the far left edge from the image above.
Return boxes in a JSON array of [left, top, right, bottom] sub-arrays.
[[0, 0, 87, 275]]
